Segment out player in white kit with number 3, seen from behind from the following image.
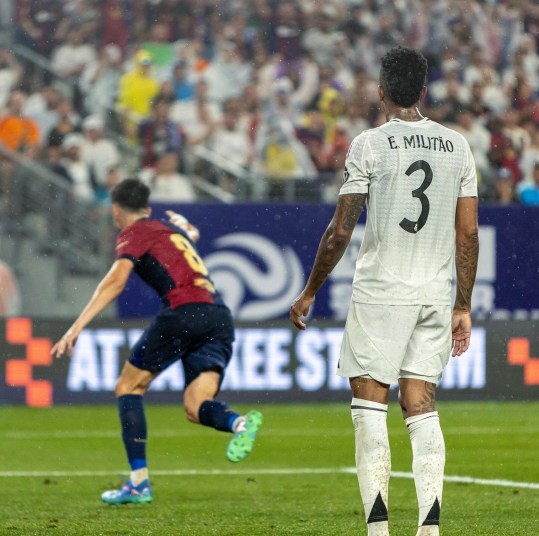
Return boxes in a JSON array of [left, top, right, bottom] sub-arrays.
[[290, 47, 479, 536]]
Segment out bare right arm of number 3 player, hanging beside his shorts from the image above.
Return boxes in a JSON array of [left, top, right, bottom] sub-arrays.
[[452, 197, 479, 356]]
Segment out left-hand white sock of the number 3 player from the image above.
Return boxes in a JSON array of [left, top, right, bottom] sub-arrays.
[[351, 398, 391, 536]]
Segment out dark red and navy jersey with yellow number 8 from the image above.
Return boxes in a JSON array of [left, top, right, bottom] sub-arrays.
[[116, 219, 224, 308]]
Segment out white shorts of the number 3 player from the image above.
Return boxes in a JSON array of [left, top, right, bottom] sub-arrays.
[[337, 301, 451, 384]]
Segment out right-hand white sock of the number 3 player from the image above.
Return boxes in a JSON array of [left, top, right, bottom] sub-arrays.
[[405, 411, 445, 536]]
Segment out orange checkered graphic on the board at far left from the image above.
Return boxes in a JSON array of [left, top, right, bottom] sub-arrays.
[[6, 318, 53, 407]]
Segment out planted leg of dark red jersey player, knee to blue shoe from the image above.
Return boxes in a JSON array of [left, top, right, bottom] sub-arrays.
[[101, 363, 157, 504]]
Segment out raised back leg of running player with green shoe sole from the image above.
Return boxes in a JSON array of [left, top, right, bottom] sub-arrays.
[[184, 370, 263, 462]]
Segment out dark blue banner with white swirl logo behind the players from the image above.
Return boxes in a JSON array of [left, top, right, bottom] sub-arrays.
[[118, 203, 539, 322]]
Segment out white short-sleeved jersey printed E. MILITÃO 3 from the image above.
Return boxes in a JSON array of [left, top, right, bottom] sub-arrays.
[[339, 118, 477, 305]]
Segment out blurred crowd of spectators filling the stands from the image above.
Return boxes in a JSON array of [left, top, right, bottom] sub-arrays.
[[0, 0, 539, 204]]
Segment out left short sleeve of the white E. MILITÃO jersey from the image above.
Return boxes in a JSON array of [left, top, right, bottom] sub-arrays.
[[339, 132, 374, 195]]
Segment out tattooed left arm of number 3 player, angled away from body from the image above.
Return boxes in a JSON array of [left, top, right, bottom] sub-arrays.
[[290, 194, 367, 329]]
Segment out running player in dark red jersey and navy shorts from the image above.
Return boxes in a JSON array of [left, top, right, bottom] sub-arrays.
[[51, 179, 262, 504]]
